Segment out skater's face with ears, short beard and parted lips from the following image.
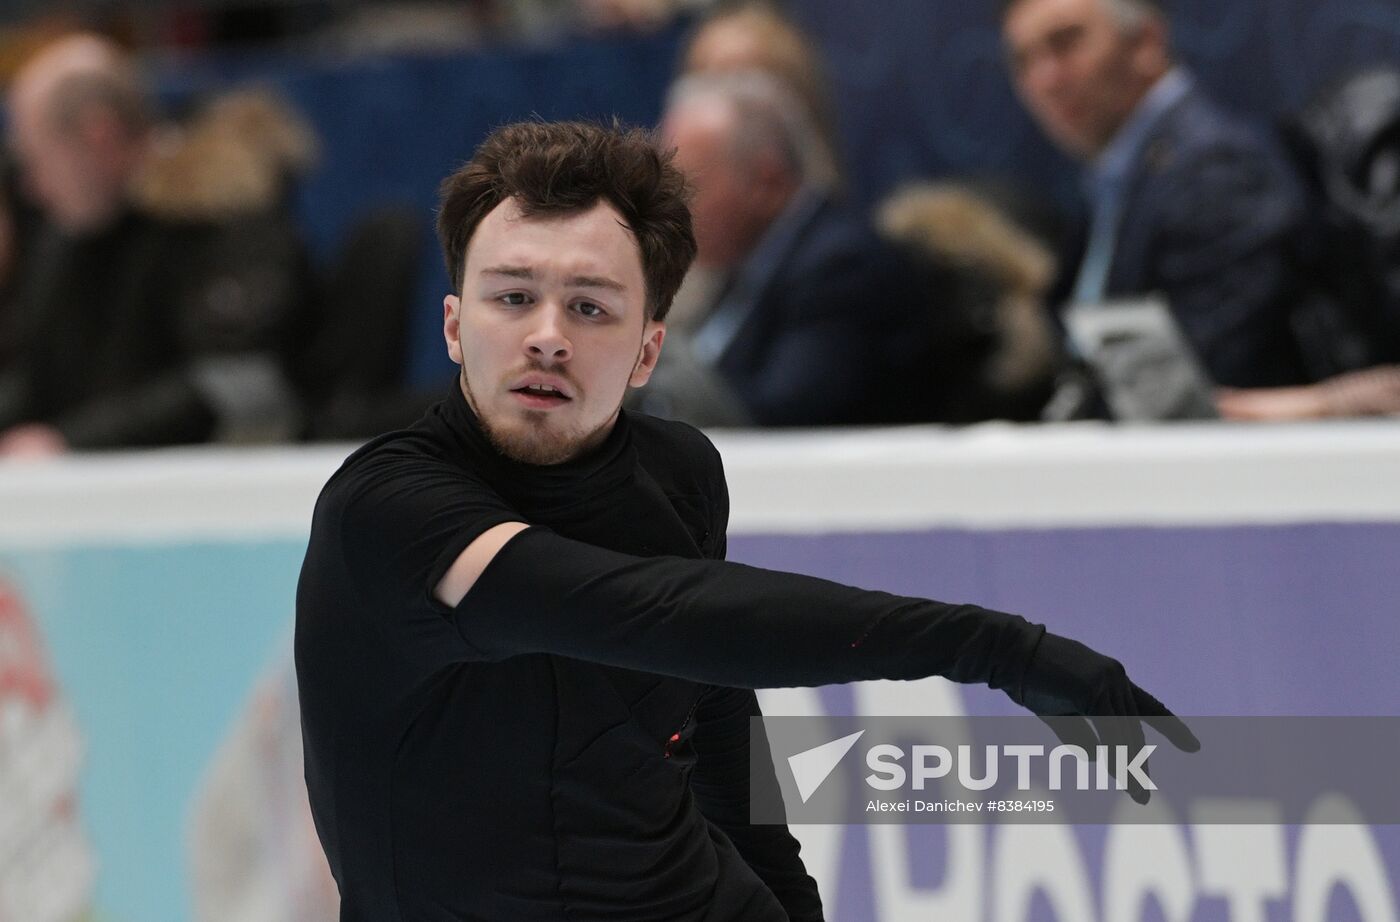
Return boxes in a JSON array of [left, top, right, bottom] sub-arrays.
[[442, 199, 665, 464]]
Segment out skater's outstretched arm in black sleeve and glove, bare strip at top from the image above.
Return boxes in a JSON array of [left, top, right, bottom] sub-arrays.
[[437, 523, 1198, 800]]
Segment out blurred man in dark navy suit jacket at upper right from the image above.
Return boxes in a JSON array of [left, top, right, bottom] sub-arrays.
[[1002, 0, 1303, 386]]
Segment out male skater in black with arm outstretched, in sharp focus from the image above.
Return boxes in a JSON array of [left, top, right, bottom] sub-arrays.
[[295, 123, 1193, 922]]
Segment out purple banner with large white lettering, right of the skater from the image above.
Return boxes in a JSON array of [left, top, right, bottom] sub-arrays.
[[729, 525, 1400, 922]]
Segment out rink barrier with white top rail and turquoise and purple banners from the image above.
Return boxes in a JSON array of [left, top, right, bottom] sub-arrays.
[[0, 427, 1400, 922]]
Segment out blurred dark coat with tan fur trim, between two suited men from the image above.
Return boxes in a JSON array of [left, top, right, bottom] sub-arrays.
[[876, 183, 1058, 423]]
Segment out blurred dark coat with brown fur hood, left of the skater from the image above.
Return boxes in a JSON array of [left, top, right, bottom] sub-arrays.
[[132, 88, 319, 444]]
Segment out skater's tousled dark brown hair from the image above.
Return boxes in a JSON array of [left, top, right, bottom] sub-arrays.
[[438, 122, 696, 320]]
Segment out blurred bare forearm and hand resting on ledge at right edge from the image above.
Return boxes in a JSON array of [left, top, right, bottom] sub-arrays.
[[1219, 365, 1400, 421]]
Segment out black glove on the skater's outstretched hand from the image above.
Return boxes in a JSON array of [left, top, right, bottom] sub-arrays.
[[1019, 631, 1201, 803]]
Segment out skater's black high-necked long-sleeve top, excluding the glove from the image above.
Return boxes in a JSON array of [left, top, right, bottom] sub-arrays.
[[297, 389, 1039, 922]]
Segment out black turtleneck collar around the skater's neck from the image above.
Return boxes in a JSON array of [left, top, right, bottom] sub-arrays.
[[434, 378, 637, 518]]
